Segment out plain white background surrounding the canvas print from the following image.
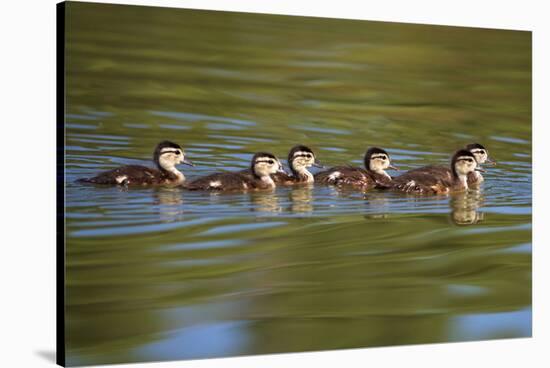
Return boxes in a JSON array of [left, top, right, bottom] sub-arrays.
[[0, 0, 550, 368]]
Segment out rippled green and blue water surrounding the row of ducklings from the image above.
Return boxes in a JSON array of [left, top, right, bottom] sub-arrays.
[[62, 3, 532, 365]]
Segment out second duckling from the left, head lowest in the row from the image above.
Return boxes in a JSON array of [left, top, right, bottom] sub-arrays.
[[185, 152, 284, 191]]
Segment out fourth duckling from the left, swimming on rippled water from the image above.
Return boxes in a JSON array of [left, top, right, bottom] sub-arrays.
[[314, 147, 397, 189]]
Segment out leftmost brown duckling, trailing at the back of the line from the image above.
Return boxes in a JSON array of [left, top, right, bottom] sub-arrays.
[[77, 141, 195, 186]]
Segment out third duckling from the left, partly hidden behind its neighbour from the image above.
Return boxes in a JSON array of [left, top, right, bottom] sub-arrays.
[[272, 144, 323, 185]]
